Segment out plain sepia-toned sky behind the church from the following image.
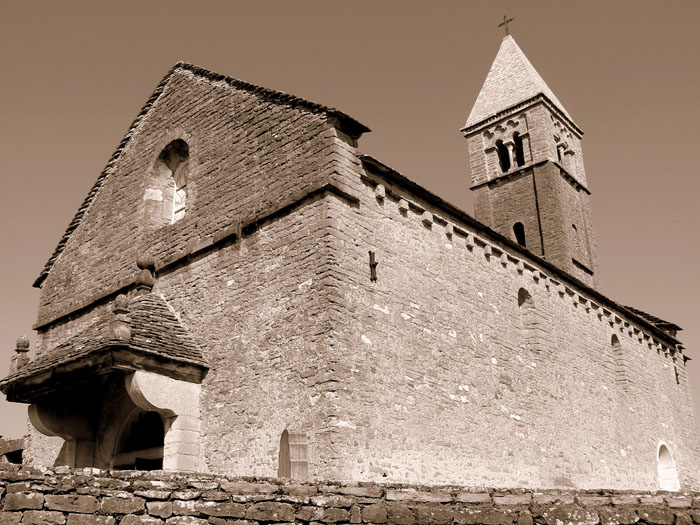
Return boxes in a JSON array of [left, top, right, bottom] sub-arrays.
[[0, 0, 700, 437]]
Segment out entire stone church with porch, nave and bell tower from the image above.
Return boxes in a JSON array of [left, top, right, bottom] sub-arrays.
[[0, 36, 700, 490]]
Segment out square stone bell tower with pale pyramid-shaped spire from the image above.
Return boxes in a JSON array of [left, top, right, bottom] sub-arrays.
[[461, 35, 598, 287]]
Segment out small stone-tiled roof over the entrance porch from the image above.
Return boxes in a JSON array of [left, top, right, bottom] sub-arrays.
[[0, 293, 207, 388]]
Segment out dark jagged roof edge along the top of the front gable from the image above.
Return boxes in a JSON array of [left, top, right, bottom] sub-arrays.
[[34, 62, 371, 288]]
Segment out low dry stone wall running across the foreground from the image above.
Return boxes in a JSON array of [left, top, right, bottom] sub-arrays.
[[0, 465, 700, 525]]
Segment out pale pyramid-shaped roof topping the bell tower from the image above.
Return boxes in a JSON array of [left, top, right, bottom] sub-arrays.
[[464, 35, 573, 128]]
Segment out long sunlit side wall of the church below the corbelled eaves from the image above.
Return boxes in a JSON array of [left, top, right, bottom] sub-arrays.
[[318, 141, 700, 490]]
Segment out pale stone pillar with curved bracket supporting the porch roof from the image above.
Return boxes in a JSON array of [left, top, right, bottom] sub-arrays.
[[126, 370, 201, 472]]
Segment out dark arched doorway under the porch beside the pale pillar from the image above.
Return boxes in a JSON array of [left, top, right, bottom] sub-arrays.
[[112, 409, 165, 470]]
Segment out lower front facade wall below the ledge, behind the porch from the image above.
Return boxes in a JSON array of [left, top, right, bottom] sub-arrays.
[[26, 188, 349, 478]]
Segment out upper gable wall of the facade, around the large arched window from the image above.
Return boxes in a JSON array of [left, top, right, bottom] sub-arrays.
[[38, 64, 350, 328]]
